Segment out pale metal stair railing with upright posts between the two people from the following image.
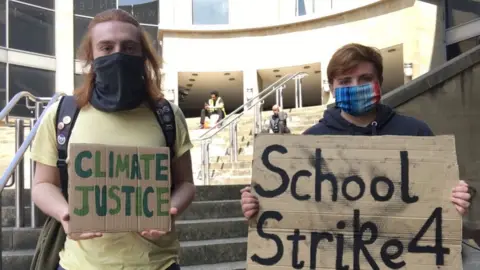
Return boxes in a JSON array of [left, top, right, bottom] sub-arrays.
[[195, 72, 307, 185]]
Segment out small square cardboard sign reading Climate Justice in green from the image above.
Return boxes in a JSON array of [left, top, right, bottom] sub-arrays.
[[68, 143, 171, 233]]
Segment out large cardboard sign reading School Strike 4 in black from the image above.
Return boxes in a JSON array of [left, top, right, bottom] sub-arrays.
[[247, 135, 462, 270]]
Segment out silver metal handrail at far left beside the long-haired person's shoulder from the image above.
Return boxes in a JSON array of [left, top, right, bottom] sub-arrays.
[[0, 92, 65, 193]]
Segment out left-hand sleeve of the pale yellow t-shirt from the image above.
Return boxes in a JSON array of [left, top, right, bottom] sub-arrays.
[[30, 101, 59, 167]]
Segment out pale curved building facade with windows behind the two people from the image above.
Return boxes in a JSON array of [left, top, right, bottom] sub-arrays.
[[0, 0, 480, 116]]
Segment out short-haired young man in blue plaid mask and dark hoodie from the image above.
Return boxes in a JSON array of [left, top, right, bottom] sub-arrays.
[[241, 44, 471, 219]]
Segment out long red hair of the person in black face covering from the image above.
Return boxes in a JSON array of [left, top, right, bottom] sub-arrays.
[[74, 9, 163, 108]]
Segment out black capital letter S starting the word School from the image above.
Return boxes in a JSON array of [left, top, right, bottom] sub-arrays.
[[253, 144, 290, 198]]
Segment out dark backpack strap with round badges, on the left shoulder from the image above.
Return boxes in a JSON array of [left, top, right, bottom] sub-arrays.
[[55, 96, 80, 201]]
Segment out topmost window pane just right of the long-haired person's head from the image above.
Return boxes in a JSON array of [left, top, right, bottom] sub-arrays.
[[118, 0, 158, 24]]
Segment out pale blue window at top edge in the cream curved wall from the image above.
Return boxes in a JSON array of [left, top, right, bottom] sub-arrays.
[[192, 0, 229, 24]]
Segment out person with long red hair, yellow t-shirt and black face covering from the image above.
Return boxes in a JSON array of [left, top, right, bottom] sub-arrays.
[[31, 9, 195, 270]]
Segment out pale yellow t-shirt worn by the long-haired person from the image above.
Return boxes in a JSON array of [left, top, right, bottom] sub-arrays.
[[31, 99, 193, 270]]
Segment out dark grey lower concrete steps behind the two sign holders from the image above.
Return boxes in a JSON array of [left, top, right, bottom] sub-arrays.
[[2, 185, 248, 270]]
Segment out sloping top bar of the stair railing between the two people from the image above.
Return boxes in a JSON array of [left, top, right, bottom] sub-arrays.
[[194, 72, 303, 141]]
